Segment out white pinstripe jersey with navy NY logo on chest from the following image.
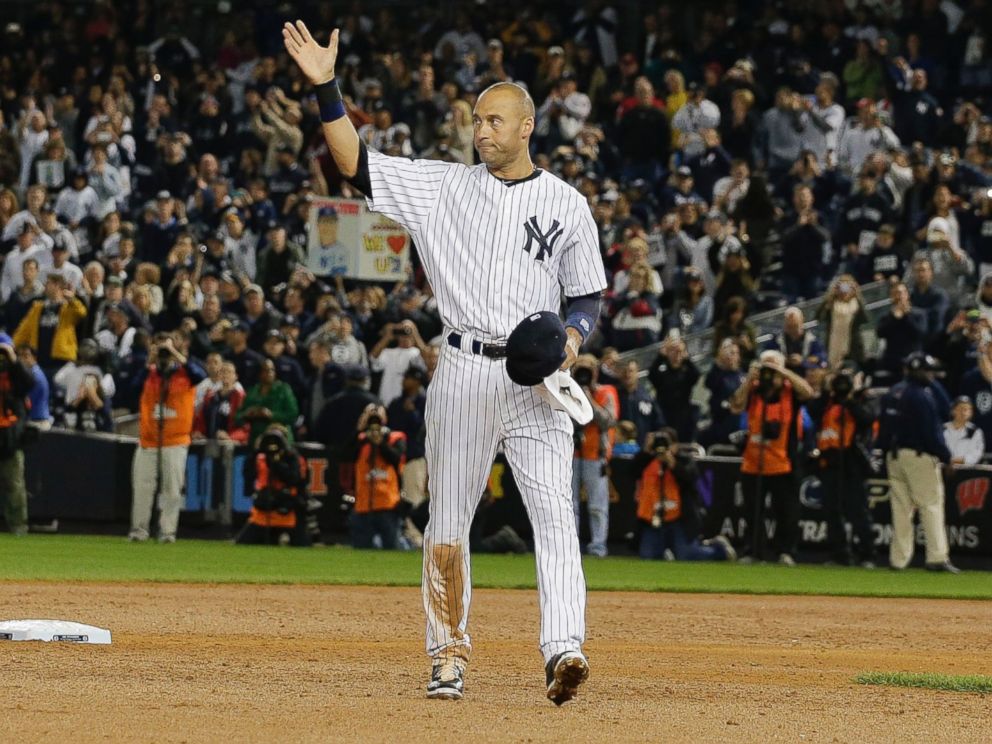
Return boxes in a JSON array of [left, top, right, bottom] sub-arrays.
[[367, 150, 606, 341]]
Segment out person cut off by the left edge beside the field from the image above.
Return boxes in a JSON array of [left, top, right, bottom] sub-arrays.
[[0, 333, 34, 535]]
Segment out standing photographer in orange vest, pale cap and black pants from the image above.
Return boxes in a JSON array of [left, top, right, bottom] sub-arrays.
[[730, 351, 813, 566]]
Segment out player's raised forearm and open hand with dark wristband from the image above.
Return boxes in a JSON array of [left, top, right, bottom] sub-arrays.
[[282, 21, 359, 178]]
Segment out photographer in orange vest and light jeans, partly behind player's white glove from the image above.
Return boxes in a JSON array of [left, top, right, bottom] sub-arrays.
[[572, 354, 620, 558]]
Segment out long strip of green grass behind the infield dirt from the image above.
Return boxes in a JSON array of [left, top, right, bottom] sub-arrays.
[[0, 534, 992, 600]]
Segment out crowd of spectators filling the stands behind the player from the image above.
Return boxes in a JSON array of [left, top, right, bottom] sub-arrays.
[[0, 0, 992, 563]]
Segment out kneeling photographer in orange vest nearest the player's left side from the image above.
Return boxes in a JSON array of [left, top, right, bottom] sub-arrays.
[[350, 403, 406, 550]]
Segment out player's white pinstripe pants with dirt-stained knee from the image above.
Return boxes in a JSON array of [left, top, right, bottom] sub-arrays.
[[422, 341, 586, 661]]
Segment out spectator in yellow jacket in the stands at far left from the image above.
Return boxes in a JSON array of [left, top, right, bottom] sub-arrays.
[[14, 273, 86, 379]]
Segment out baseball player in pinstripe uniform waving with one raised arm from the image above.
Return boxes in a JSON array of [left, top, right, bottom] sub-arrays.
[[283, 21, 606, 705]]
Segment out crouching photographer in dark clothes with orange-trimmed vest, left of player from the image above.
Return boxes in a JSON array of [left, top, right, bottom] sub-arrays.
[[234, 424, 311, 547]]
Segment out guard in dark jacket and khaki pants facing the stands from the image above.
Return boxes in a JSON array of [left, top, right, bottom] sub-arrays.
[[877, 351, 960, 573]]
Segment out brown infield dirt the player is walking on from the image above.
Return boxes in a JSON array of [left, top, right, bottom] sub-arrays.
[[0, 583, 992, 744]]
